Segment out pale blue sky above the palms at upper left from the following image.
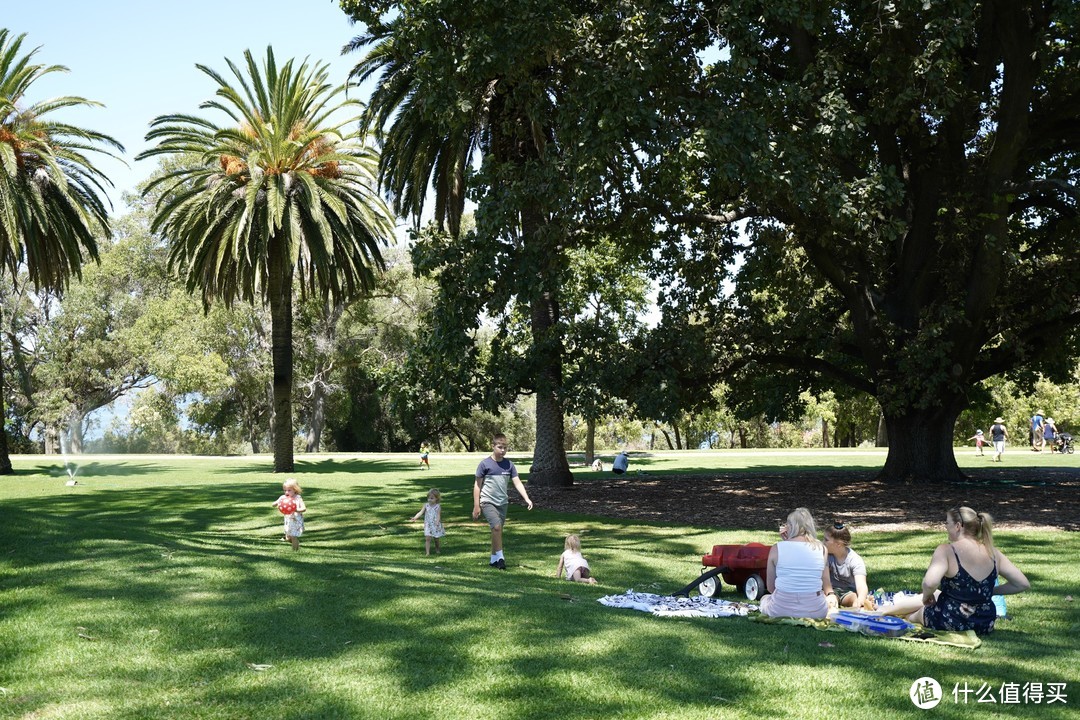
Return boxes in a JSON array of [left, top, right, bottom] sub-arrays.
[[6, 0, 363, 210]]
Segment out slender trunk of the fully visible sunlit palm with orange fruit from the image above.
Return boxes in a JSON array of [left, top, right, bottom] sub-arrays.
[[267, 250, 294, 473]]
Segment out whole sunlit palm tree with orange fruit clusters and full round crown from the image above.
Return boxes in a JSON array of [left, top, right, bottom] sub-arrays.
[[139, 47, 393, 473]]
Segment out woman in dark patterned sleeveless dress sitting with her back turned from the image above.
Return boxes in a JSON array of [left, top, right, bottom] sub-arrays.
[[887, 507, 1031, 635]]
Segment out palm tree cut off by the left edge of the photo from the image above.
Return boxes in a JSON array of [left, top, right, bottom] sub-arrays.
[[0, 28, 123, 475]]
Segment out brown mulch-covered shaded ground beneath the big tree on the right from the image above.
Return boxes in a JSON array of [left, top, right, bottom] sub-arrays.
[[529, 467, 1080, 532]]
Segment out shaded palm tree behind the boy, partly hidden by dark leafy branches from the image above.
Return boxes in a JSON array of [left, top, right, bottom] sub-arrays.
[[343, 19, 573, 486]]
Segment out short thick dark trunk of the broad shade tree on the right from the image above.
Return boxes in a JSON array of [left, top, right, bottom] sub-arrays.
[[878, 407, 964, 485]]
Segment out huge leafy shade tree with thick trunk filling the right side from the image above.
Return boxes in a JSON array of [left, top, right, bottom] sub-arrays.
[[638, 0, 1080, 481]]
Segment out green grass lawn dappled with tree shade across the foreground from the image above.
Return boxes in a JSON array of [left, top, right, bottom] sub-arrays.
[[0, 448, 1080, 720]]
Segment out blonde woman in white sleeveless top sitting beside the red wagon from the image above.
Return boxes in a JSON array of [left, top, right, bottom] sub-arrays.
[[761, 507, 836, 619]]
